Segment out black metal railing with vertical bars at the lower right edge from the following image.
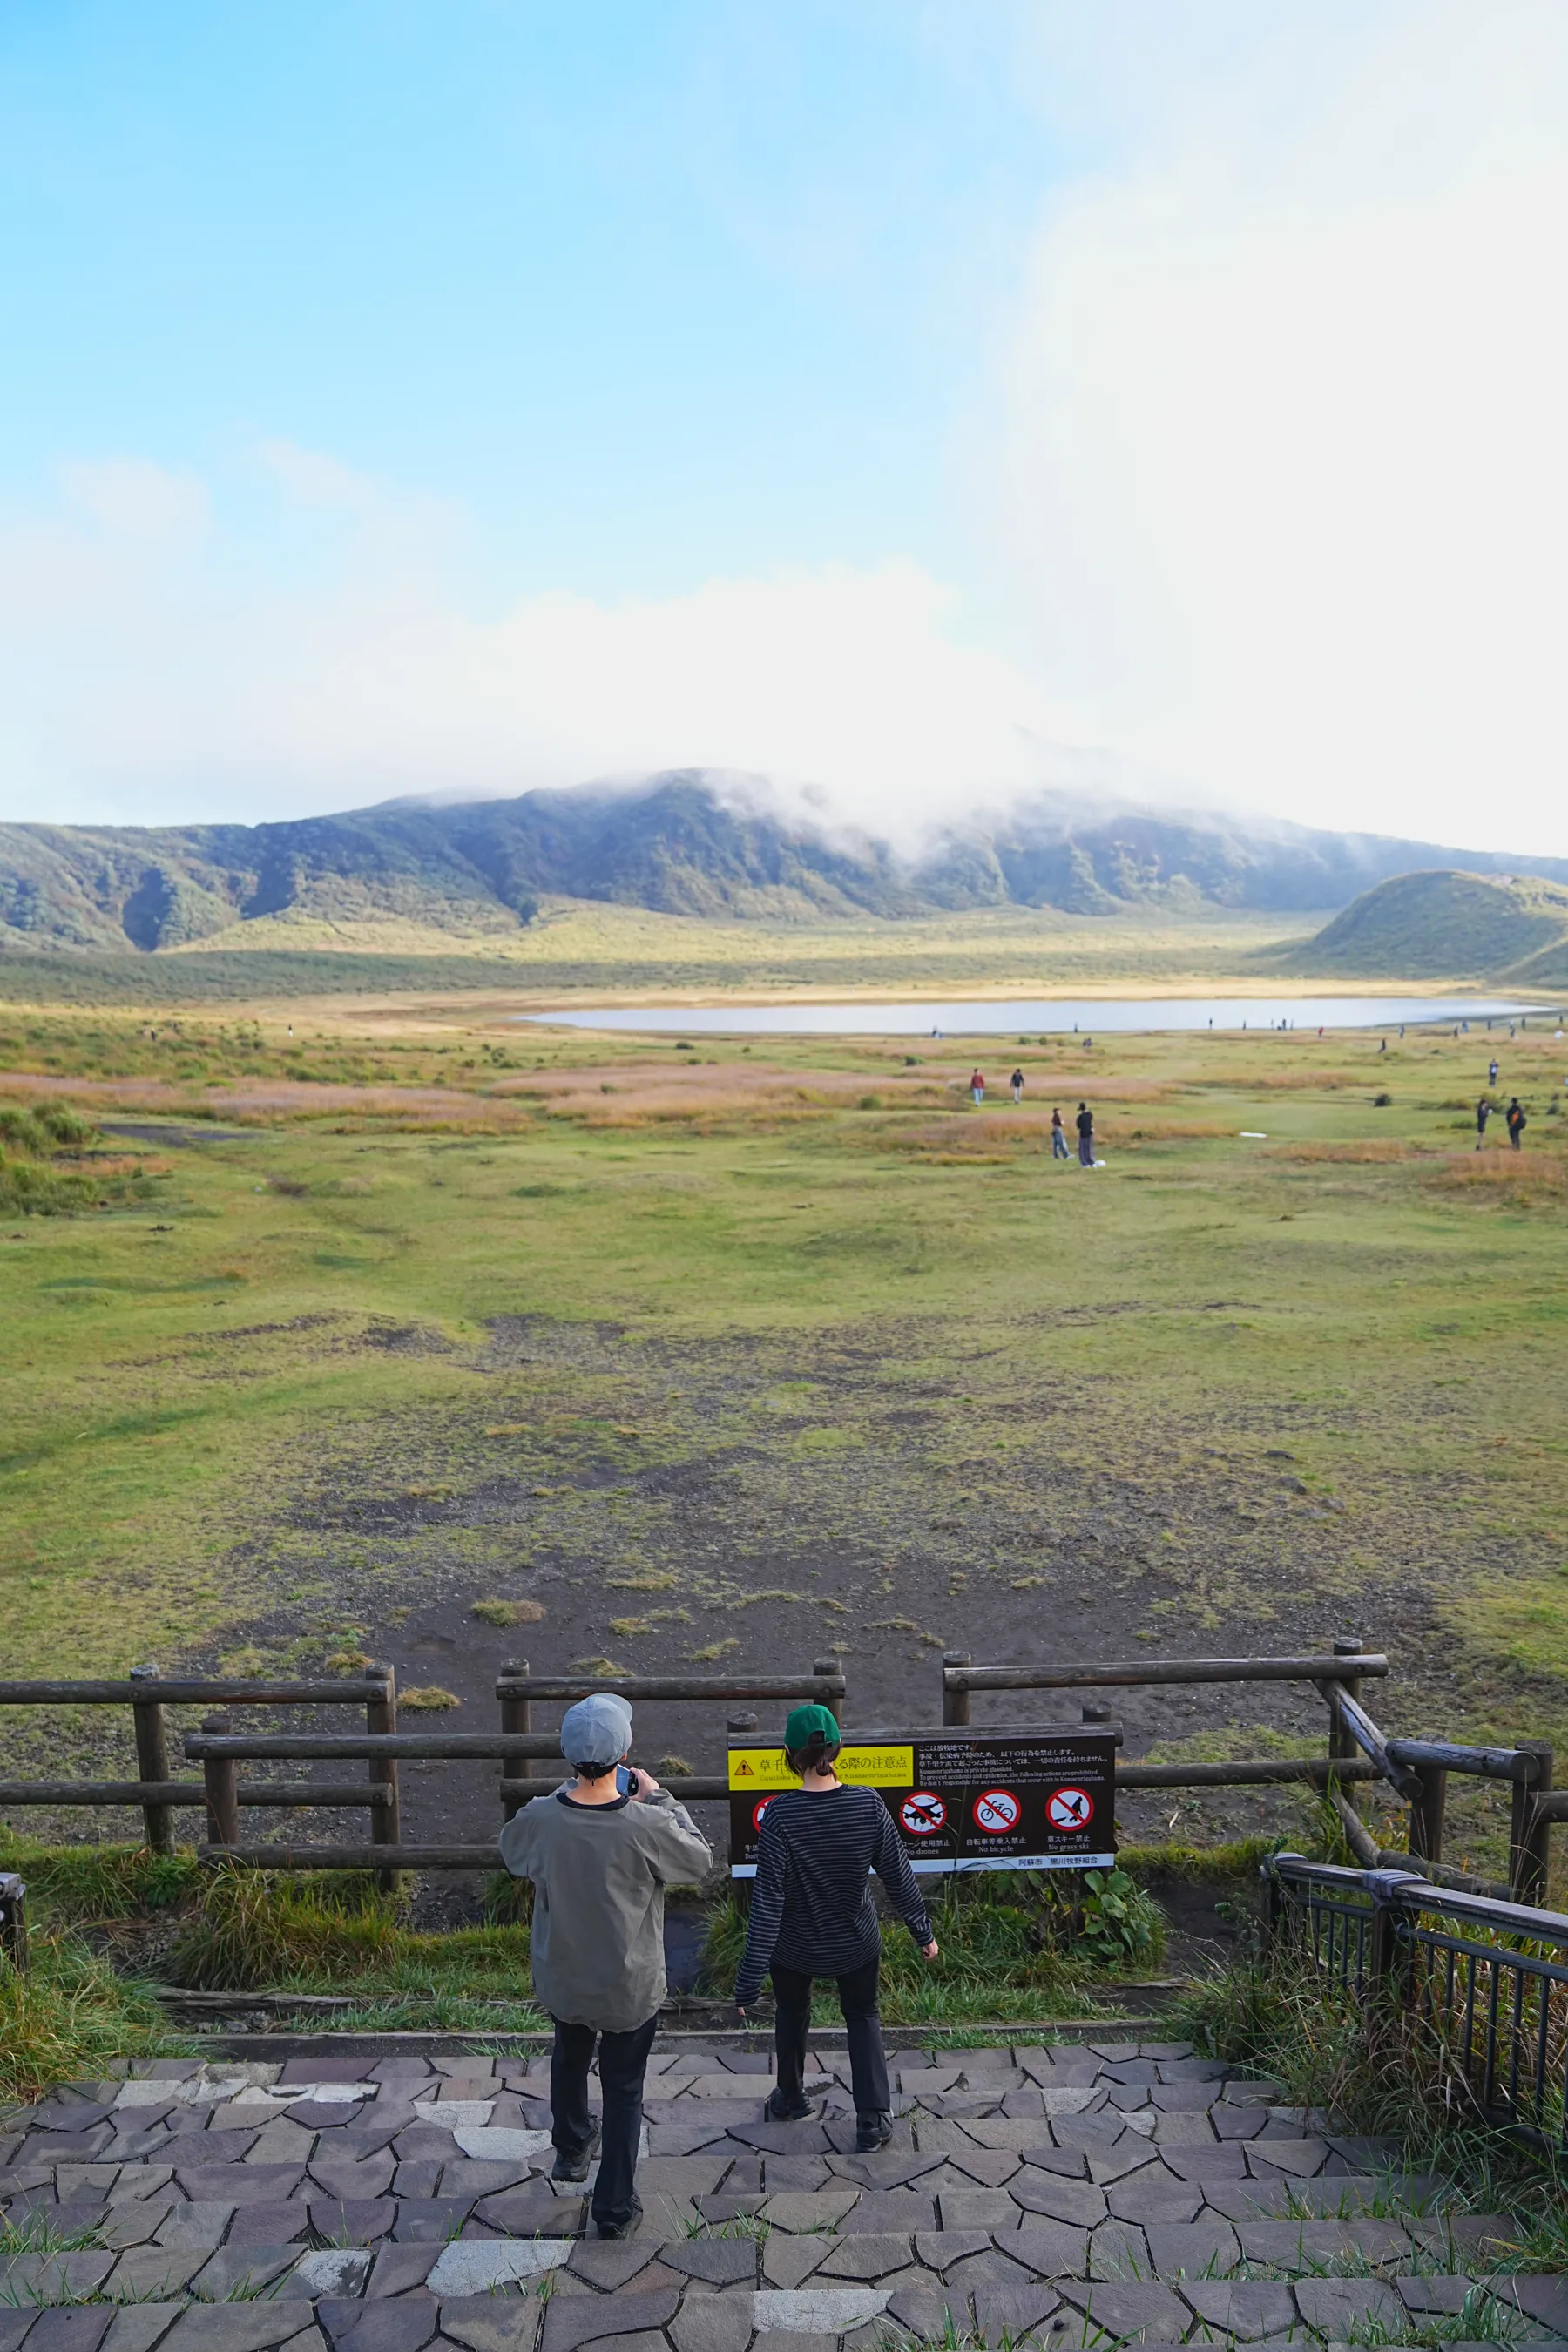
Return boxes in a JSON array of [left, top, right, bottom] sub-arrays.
[[1267, 1854, 1568, 2154]]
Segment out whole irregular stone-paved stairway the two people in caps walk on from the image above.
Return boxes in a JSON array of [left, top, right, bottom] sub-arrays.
[[0, 2042, 1568, 2352]]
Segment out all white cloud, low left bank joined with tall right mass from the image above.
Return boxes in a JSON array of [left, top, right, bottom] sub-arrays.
[[0, 0, 1568, 854]]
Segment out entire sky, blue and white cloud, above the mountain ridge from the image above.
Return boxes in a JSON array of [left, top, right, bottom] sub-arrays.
[[0, 0, 1568, 854]]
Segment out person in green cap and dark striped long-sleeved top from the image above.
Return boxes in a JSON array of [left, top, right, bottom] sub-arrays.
[[736, 1707, 936, 2154]]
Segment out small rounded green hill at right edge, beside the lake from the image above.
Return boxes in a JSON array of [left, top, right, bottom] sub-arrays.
[[1293, 873, 1568, 985]]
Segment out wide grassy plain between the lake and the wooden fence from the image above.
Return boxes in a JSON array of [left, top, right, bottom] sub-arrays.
[[0, 1000, 1568, 1858]]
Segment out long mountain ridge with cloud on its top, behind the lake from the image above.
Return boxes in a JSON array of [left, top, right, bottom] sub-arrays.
[[0, 769, 1568, 955]]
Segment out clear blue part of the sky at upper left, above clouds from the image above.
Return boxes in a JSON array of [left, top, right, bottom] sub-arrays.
[[0, 0, 1053, 595]]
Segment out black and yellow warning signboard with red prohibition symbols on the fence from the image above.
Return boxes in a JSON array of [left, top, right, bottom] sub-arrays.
[[729, 1729, 1117, 1879]]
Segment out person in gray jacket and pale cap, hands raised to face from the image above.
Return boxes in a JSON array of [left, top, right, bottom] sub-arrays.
[[501, 1691, 713, 2237]]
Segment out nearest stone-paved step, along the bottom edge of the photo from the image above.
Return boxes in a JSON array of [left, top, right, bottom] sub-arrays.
[[0, 2239, 1568, 2352]]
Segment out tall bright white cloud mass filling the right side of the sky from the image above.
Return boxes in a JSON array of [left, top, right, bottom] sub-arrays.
[[978, 0, 1568, 851]]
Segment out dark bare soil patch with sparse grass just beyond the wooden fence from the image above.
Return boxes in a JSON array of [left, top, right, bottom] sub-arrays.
[[15, 1317, 1521, 1872]]
